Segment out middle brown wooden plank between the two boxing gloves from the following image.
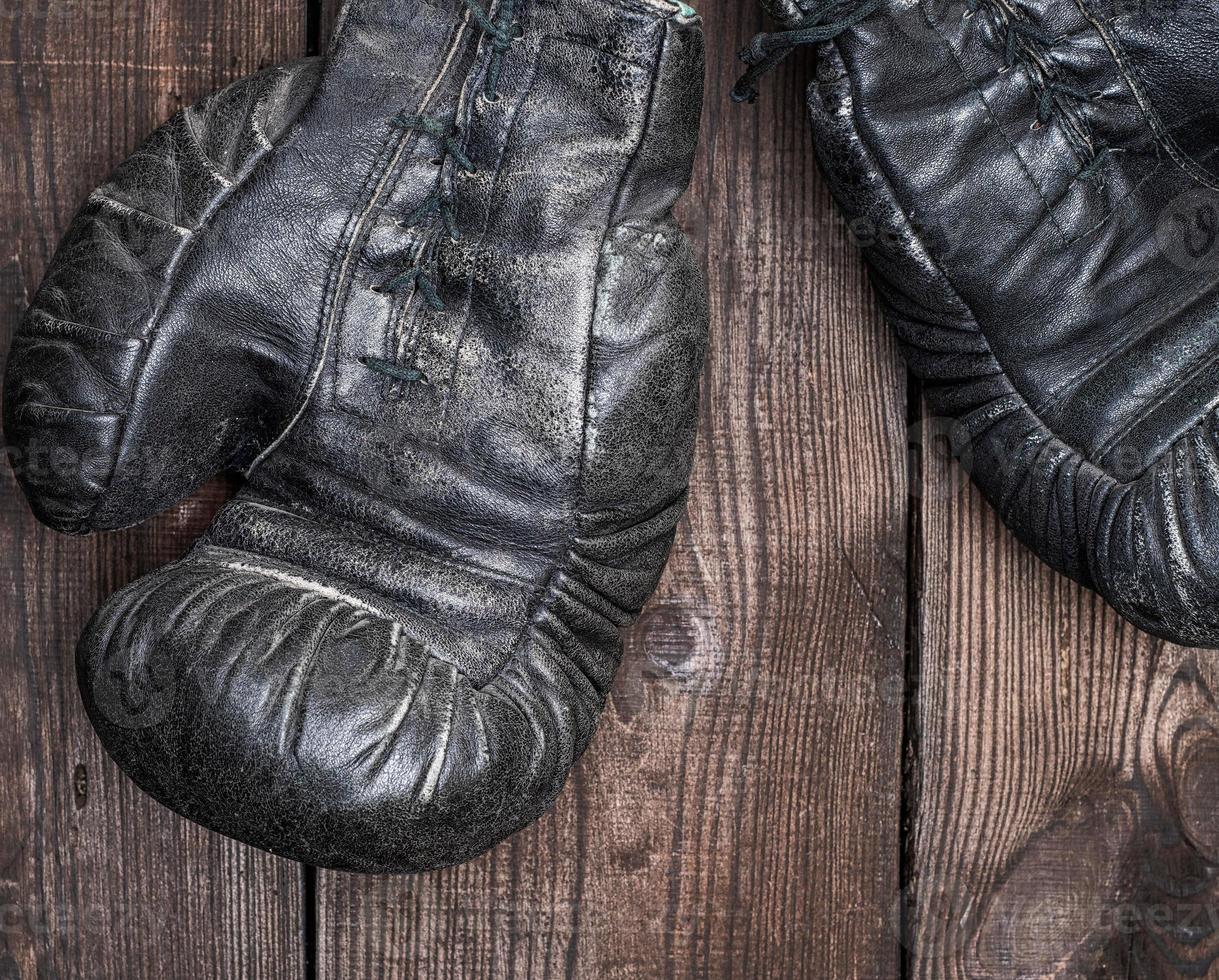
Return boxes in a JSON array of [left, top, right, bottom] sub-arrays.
[[318, 0, 907, 980]]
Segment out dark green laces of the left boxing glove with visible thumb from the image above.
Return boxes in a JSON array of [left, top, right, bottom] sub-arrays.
[[361, 0, 523, 382]]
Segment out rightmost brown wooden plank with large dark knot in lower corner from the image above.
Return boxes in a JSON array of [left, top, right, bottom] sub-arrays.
[[904, 419, 1219, 980]]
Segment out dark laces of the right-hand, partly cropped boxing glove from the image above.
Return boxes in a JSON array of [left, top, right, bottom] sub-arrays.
[[733, 0, 1123, 180]]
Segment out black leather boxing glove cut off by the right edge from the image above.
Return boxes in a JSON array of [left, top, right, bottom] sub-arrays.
[[734, 0, 1219, 646]]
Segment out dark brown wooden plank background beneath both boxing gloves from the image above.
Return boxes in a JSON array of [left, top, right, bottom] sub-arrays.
[[0, 0, 1219, 980]]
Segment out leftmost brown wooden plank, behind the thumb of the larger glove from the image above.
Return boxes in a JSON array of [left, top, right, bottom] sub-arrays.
[[0, 0, 305, 980]]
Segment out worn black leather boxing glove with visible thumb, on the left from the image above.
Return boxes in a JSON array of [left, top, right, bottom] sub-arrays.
[[5, 0, 707, 872]]
